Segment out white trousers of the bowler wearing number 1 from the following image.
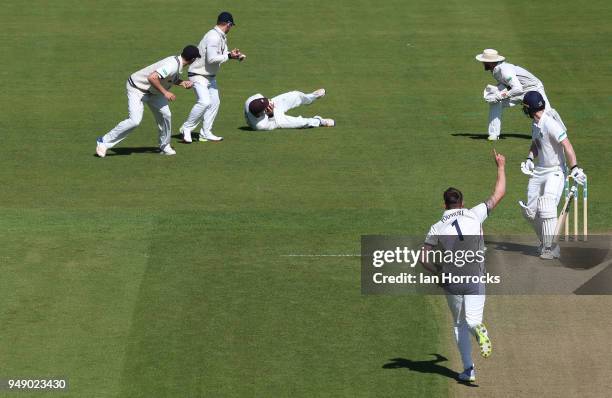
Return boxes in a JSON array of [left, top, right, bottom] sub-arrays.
[[446, 294, 485, 369]]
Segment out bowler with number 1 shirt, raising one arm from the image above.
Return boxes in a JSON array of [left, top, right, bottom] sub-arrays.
[[422, 152, 506, 382]]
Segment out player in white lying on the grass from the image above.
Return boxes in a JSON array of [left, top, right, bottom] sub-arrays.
[[244, 88, 336, 130]]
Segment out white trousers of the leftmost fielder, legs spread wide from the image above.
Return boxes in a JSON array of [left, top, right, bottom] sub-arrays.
[[102, 83, 172, 148]]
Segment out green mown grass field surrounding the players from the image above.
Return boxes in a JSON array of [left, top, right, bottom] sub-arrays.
[[0, 0, 612, 397]]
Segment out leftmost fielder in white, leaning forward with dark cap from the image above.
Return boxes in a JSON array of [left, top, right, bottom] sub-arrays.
[[96, 46, 200, 158]]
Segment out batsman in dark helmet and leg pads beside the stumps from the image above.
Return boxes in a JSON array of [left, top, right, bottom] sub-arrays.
[[519, 91, 586, 260]]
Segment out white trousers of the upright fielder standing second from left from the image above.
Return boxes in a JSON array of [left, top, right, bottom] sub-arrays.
[[182, 75, 221, 137]]
